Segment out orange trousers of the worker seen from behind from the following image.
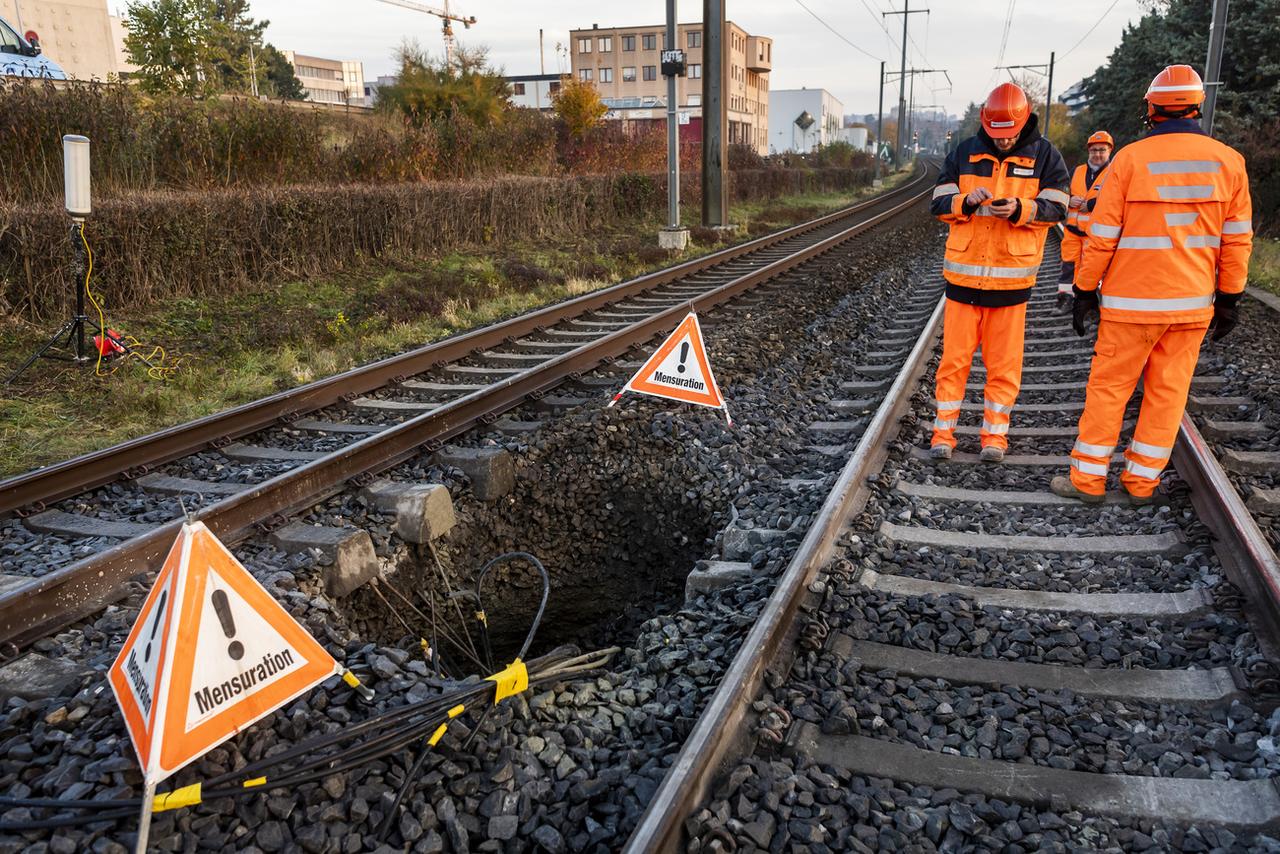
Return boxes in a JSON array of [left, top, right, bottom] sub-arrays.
[[1071, 318, 1208, 497]]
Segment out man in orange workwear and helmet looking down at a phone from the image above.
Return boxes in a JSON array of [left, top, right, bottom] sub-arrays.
[[931, 83, 1070, 462]]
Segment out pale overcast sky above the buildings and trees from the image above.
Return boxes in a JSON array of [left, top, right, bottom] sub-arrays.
[[222, 0, 1160, 113]]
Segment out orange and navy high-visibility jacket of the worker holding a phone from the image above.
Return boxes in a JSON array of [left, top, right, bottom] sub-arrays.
[[932, 115, 1071, 306]]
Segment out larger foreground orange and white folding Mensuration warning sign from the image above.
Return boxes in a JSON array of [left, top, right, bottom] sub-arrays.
[[108, 522, 342, 782]]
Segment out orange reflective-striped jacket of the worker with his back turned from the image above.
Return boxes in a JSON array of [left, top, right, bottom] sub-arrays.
[[1075, 119, 1253, 324]]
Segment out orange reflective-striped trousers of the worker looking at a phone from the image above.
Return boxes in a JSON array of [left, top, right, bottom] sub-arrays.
[[931, 300, 1027, 449]]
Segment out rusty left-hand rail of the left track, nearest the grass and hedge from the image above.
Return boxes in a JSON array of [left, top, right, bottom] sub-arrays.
[[0, 166, 920, 515]]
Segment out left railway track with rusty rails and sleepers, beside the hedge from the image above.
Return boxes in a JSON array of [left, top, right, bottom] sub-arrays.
[[0, 168, 933, 656]]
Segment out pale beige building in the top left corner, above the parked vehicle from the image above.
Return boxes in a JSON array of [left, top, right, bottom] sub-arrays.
[[0, 0, 127, 81]]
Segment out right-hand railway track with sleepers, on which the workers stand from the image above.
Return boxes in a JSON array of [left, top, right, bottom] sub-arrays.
[[626, 239, 1280, 854]]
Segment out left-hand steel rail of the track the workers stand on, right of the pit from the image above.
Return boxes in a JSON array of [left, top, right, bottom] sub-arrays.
[[623, 281, 946, 854]]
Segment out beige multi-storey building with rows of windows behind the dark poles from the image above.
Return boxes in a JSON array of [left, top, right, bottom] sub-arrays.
[[570, 20, 773, 154]]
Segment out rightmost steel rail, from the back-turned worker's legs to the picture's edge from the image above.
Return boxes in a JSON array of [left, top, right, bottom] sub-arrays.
[[1171, 415, 1280, 654]]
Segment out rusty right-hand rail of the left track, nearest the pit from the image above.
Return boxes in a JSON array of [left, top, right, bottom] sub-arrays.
[[0, 163, 929, 652]]
